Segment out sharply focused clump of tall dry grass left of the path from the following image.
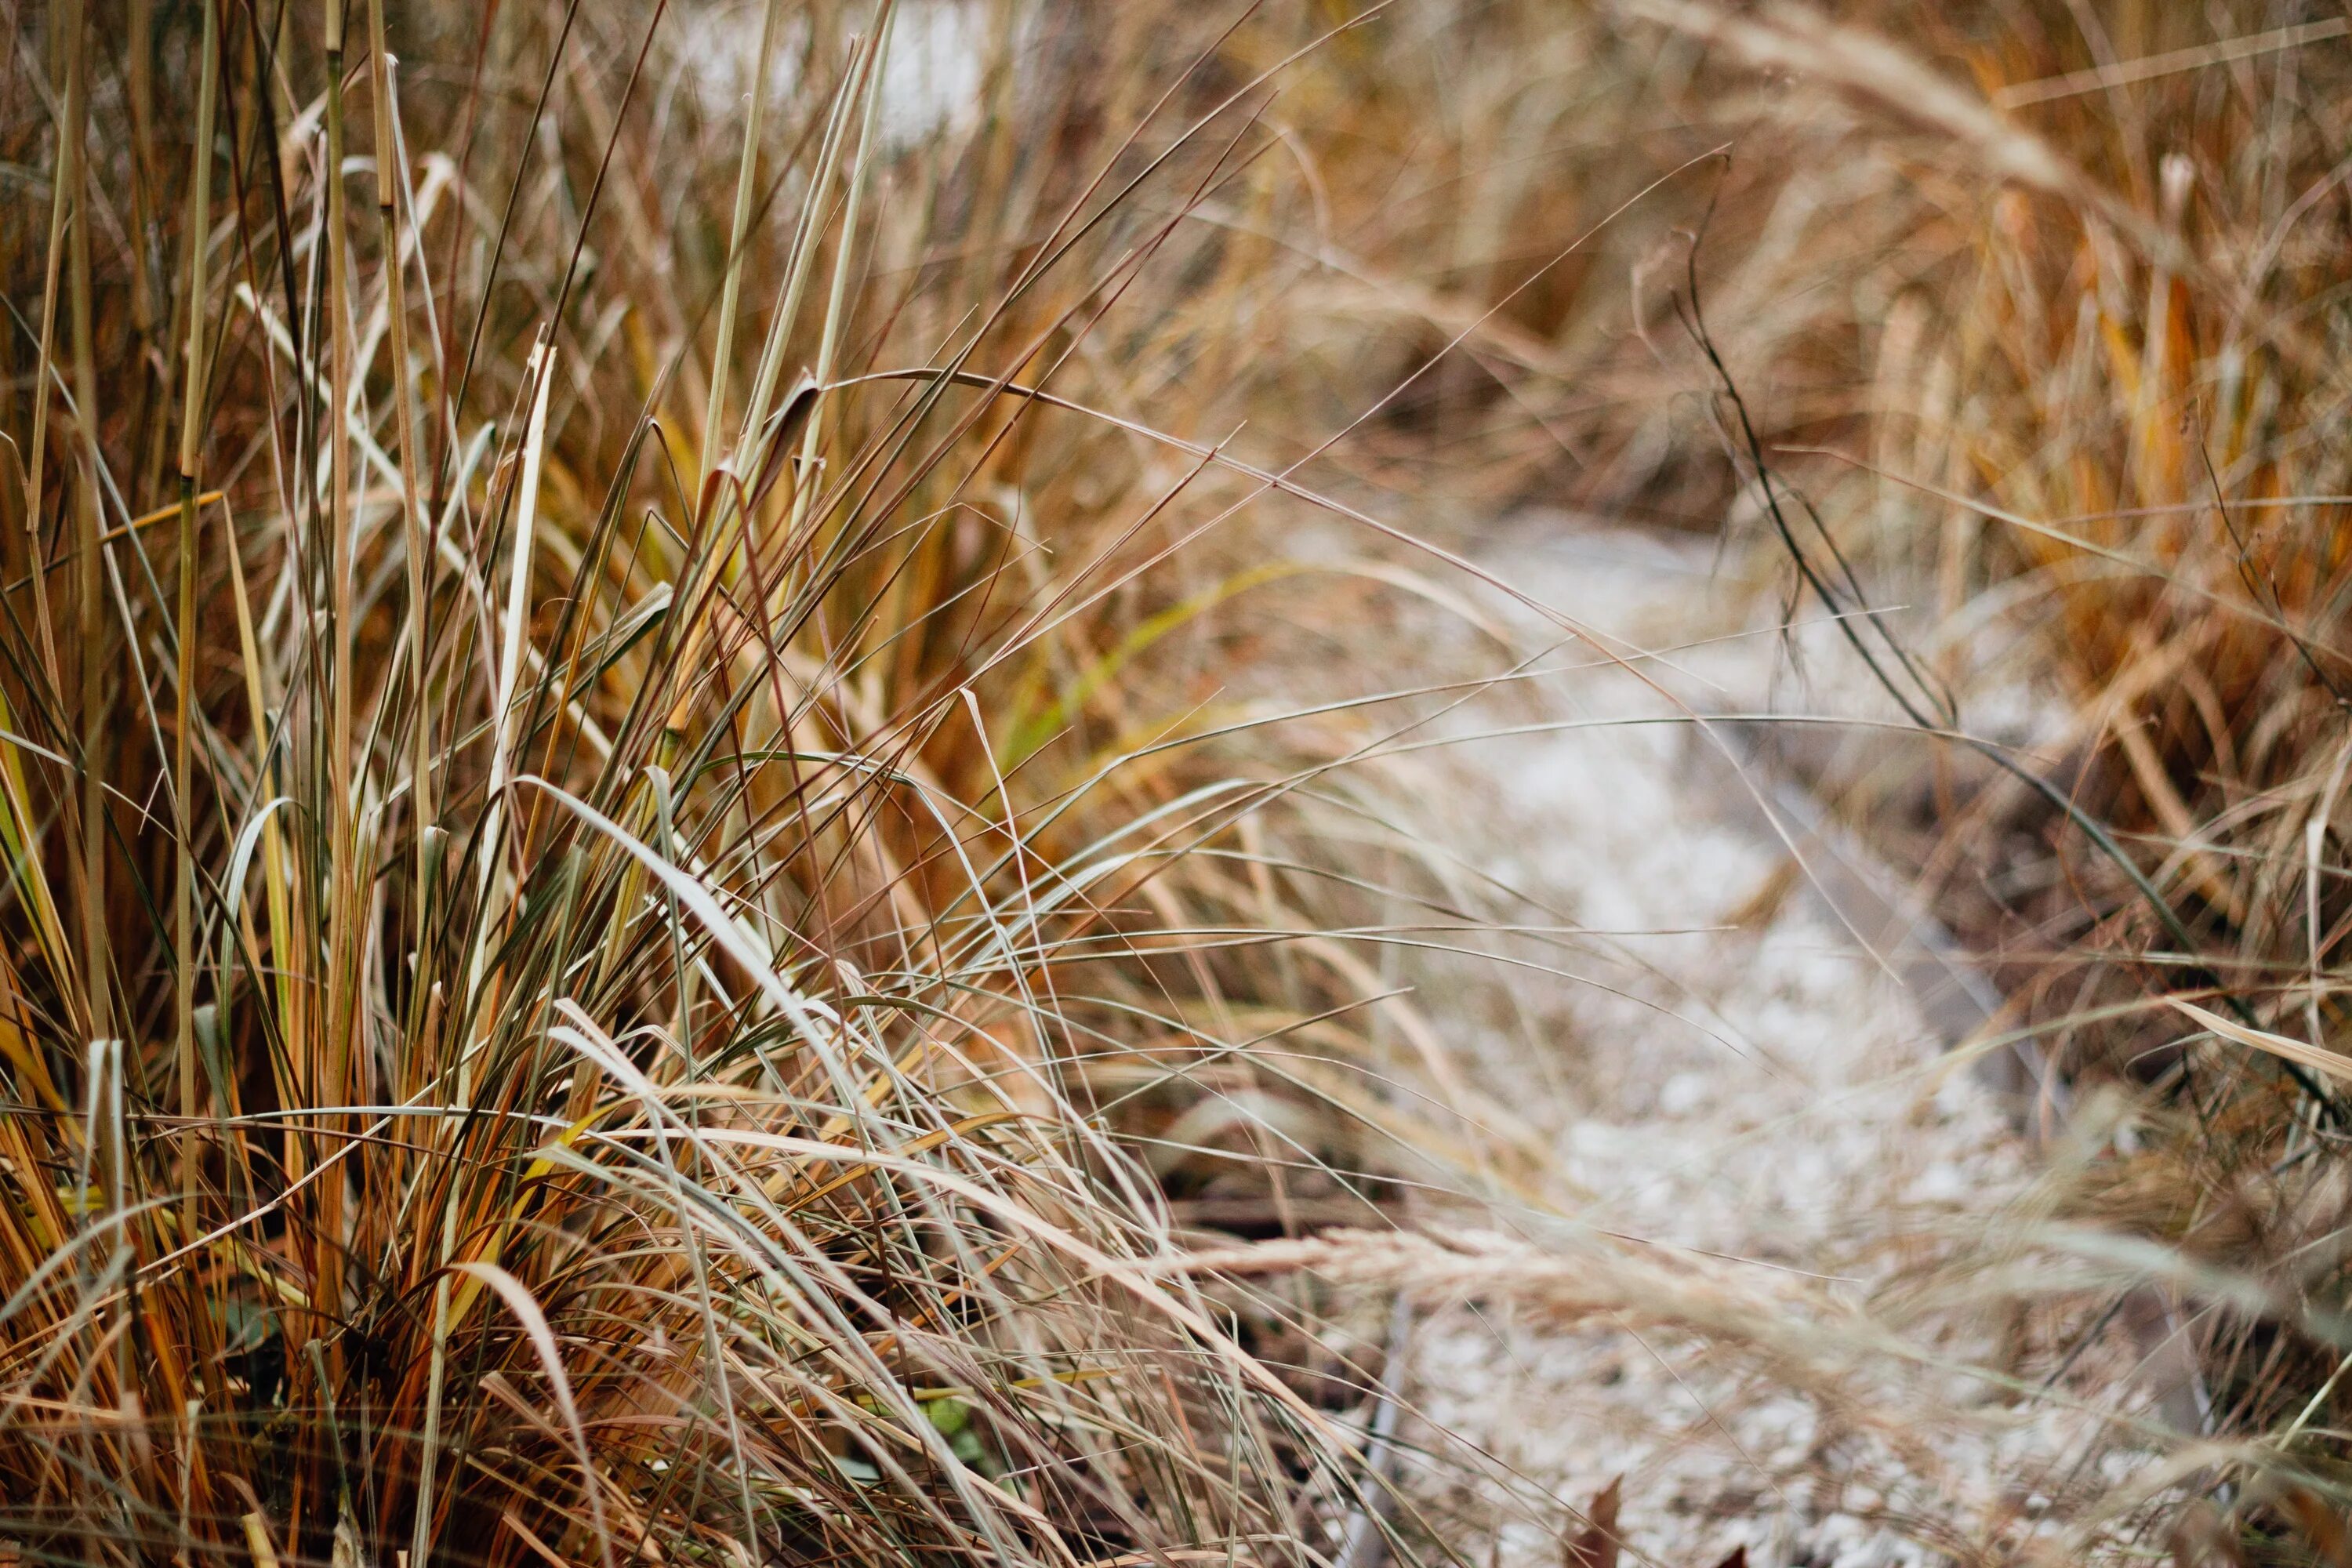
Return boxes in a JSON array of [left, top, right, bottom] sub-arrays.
[[0, 0, 1430, 1568]]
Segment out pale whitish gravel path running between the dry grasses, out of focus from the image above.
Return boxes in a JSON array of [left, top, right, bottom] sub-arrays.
[[1374, 522, 2140, 1568]]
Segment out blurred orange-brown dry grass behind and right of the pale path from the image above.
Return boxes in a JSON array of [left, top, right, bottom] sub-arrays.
[[1077, 0, 2352, 1556]]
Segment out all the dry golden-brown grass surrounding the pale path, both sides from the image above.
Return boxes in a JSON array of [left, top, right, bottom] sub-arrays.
[[13, 0, 2352, 1568]]
